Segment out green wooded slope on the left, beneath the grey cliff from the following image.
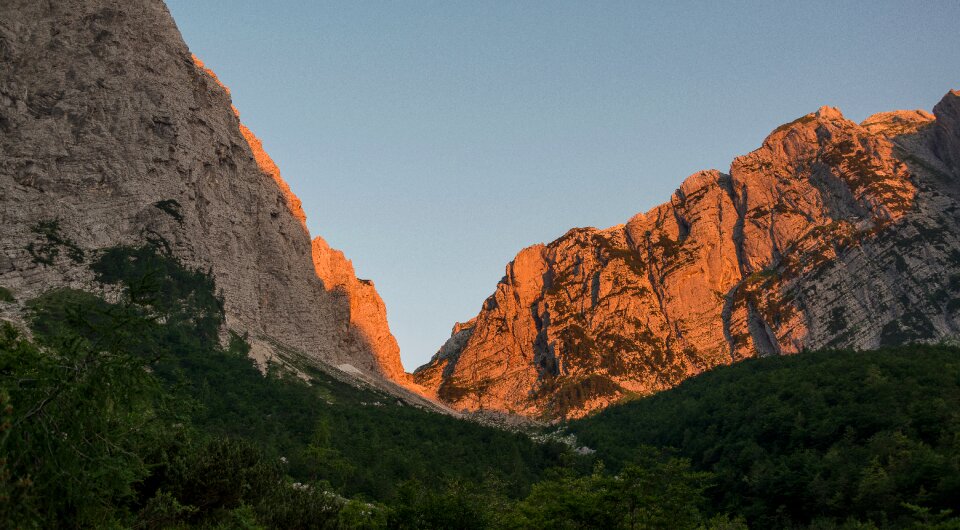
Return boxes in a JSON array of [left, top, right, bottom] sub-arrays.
[[0, 245, 566, 528]]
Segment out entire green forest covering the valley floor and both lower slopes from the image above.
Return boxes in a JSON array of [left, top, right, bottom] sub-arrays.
[[0, 232, 960, 529]]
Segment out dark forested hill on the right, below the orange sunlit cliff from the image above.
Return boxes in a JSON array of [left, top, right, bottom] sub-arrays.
[[570, 346, 960, 527]]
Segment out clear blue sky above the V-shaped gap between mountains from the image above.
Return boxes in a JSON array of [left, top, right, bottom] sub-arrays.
[[168, 0, 960, 371]]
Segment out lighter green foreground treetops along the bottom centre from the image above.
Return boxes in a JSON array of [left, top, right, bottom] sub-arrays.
[[390, 447, 724, 530]]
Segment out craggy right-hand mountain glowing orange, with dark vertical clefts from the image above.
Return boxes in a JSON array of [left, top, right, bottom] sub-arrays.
[[415, 92, 960, 417]]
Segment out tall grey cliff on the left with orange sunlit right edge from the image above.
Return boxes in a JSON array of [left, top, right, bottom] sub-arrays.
[[0, 0, 425, 403]]
